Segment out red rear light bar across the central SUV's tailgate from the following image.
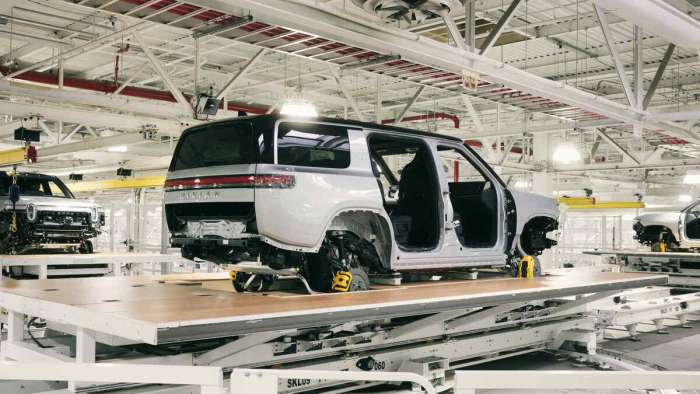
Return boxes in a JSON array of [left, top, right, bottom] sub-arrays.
[[165, 174, 296, 191]]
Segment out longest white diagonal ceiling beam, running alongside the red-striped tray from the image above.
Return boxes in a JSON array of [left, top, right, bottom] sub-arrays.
[[179, 0, 688, 142]]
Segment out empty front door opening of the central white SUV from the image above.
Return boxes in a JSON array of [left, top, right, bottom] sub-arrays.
[[438, 147, 498, 248]]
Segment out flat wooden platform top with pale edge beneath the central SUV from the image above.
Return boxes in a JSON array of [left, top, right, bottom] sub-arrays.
[[0, 272, 667, 344]]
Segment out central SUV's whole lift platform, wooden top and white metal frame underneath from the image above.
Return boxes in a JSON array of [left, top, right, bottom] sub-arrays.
[[0, 272, 667, 392]]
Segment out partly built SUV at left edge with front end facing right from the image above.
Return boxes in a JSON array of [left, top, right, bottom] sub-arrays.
[[0, 172, 105, 254]]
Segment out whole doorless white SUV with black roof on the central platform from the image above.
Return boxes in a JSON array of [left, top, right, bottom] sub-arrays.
[[165, 115, 558, 291]]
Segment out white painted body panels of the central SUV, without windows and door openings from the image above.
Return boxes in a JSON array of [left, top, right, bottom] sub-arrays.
[[164, 118, 559, 271]]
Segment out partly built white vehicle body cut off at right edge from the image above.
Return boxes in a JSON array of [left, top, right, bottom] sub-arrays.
[[632, 200, 700, 252]]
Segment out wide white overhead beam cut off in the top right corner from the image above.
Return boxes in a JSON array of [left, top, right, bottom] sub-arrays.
[[597, 0, 700, 50]]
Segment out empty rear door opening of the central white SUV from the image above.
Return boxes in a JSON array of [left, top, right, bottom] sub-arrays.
[[369, 136, 440, 250]]
